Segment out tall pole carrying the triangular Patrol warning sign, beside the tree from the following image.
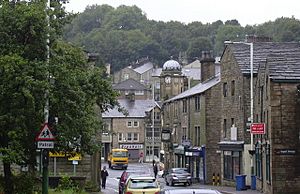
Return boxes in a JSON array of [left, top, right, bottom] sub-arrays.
[[42, 0, 50, 194]]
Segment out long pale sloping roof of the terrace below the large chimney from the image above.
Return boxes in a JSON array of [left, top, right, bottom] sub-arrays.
[[165, 74, 221, 102]]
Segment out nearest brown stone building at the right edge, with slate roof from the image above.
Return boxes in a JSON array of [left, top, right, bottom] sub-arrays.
[[254, 53, 300, 194]]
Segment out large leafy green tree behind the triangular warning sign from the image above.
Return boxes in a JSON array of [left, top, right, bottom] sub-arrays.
[[0, 1, 117, 194]]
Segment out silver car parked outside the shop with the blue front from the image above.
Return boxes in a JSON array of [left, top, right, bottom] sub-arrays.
[[164, 168, 192, 186]]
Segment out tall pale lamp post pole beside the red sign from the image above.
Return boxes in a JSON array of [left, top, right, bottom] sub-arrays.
[[250, 42, 254, 175]]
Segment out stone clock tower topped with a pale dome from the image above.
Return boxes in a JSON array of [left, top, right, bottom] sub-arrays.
[[160, 59, 185, 101]]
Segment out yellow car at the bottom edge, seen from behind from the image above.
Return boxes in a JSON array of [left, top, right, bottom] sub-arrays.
[[124, 176, 160, 194]]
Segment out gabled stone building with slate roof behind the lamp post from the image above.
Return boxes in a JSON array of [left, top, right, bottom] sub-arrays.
[[219, 42, 299, 190]]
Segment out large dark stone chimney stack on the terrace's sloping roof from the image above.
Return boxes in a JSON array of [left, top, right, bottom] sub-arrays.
[[200, 51, 215, 82]]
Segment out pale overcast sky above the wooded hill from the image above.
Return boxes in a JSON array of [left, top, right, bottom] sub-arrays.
[[66, 0, 300, 26]]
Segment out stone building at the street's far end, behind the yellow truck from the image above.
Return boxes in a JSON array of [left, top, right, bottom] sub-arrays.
[[102, 99, 160, 161]]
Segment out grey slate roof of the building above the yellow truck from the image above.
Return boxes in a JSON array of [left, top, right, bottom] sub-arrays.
[[102, 99, 159, 118]]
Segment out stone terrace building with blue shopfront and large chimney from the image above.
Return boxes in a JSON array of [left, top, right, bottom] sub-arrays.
[[161, 52, 220, 183]]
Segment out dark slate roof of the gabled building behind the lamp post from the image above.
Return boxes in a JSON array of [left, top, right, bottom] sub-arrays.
[[226, 42, 300, 74]]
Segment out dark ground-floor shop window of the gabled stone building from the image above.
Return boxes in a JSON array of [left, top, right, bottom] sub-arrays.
[[223, 151, 241, 180]]
